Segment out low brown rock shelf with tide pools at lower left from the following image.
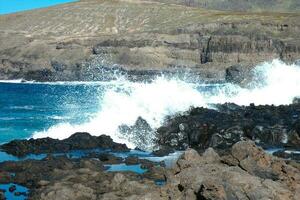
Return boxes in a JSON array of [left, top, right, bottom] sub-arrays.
[[0, 148, 164, 199]]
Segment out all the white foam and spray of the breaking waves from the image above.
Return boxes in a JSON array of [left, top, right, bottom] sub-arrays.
[[28, 60, 300, 148]]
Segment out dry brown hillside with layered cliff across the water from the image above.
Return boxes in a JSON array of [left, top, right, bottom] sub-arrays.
[[0, 0, 300, 81]]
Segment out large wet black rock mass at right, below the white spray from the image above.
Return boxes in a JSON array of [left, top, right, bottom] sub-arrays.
[[157, 104, 300, 155]]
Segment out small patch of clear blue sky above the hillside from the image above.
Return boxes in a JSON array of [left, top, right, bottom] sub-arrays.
[[0, 0, 77, 15]]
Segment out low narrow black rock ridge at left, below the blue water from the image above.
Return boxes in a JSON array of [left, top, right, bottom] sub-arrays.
[[0, 133, 129, 157]]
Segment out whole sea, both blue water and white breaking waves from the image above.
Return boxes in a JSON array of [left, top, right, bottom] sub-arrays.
[[0, 60, 300, 148]]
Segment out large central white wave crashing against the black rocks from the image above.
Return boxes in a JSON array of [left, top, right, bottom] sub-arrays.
[[33, 78, 205, 147]]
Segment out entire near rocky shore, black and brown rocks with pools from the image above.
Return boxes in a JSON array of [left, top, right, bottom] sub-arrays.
[[0, 103, 300, 200]]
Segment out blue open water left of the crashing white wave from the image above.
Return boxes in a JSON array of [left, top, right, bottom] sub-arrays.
[[0, 83, 103, 143]]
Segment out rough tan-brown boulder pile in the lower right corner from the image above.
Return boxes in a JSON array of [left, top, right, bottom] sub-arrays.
[[163, 141, 300, 199]]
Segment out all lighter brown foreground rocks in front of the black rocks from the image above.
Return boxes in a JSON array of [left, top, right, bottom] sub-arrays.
[[0, 141, 300, 200]]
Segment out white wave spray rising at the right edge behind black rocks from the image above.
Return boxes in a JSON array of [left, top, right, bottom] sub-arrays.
[[209, 60, 300, 105]]
